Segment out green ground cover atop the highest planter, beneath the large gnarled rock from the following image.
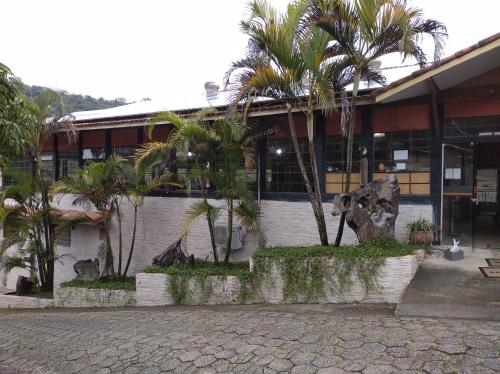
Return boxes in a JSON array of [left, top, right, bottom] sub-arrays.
[[253, 237, 415, 259]]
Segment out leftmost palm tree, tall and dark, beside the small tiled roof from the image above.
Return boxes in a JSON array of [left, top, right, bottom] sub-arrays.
[[0, 90, 77, 289]]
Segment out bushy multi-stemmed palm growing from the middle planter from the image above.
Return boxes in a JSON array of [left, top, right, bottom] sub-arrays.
[[138, 109, 265, 263]]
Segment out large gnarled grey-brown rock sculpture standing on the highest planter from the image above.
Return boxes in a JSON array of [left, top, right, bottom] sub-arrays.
[[332, 174, 399, 243]]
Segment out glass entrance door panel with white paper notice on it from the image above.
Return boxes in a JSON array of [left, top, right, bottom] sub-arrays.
[[441, 144, 477, 247]]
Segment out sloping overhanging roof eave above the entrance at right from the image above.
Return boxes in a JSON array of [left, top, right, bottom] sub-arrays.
[[372, 33, 500, 103]]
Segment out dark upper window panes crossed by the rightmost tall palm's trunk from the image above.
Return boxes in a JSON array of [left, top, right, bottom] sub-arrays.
[[325, 135, 361, 173]]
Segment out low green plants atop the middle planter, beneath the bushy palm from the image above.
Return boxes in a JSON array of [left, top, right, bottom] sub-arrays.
[[144, 260, 250, 277]]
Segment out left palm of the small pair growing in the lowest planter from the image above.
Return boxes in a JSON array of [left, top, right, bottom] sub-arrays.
[[51, 155, 125, 279]]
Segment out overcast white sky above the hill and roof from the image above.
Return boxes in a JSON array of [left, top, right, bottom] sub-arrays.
[[0, 0, 500, 102]]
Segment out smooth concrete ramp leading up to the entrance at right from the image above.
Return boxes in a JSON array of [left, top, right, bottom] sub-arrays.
[[397, 250, 500, 321]]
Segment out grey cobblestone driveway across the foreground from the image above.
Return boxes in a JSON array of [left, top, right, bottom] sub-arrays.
[[0, 307, 500, 374]]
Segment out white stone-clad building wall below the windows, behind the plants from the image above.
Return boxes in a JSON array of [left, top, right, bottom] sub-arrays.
[[58, 193, 432, 282]]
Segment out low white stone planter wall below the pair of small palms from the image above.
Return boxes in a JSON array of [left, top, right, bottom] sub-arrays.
[[54, 287, 136, 308]]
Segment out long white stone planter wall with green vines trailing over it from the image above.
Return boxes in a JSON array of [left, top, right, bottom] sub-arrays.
[[136, 250, 424, 306]]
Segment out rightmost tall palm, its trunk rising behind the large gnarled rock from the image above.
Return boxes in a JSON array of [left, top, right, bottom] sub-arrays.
[[302, 0, 447, 246]]
